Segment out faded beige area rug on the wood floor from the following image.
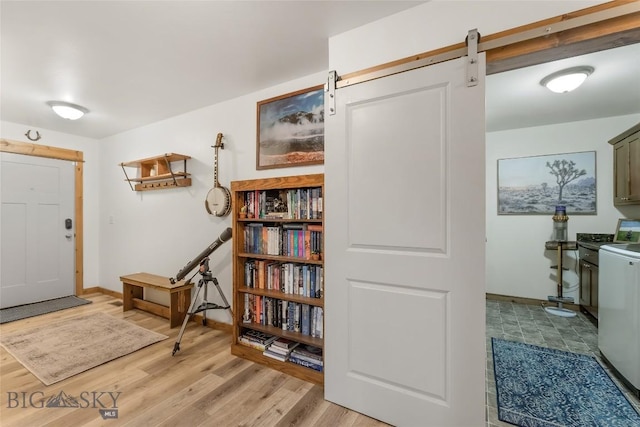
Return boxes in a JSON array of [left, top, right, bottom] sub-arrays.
[[0, 313, 168, 385]]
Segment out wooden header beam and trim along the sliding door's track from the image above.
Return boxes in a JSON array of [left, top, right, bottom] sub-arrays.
[[336, 0, 640, 88]]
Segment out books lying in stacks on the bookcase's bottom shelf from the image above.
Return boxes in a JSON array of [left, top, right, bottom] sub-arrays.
[[238, 329, 324, 372]]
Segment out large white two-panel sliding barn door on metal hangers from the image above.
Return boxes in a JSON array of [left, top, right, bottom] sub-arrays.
[[325, 55, 486, 426]]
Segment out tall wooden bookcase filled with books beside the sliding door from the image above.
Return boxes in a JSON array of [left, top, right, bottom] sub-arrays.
[[231, 174, 324, 384]]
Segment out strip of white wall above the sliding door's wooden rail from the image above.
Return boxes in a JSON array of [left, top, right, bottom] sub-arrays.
[[329, 0, 607, 75]]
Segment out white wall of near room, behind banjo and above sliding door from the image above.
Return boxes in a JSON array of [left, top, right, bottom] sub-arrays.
[[1, 1, 616, 322]]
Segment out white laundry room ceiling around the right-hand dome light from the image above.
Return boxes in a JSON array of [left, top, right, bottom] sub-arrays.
[[485, 43, 640, 132]]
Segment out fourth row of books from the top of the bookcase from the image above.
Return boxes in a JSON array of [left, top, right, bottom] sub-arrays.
[[242, 294, 324, 338]]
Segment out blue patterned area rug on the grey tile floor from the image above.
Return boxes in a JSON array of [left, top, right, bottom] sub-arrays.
[[491, 338, 640, 427]]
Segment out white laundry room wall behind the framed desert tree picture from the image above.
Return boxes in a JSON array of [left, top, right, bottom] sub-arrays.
[[486, 114, 640, 302]]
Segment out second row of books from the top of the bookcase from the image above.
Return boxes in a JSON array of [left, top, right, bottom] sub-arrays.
[[244, 222, 322, 259]]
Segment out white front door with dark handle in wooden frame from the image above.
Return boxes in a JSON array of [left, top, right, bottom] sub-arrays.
[[0, 152, 75, 308]]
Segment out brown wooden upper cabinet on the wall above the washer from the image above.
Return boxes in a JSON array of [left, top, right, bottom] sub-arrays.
[[609, 123, 640, 206]]
